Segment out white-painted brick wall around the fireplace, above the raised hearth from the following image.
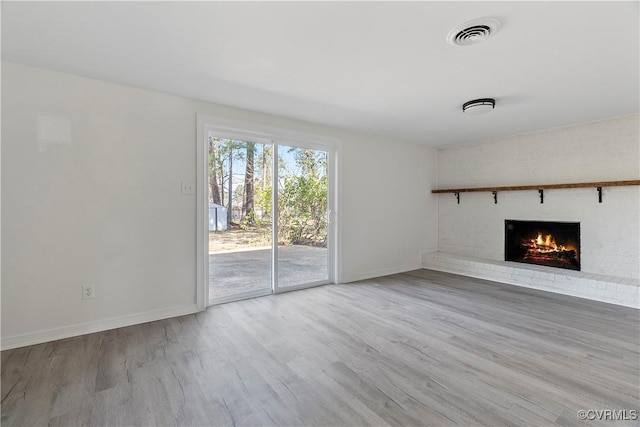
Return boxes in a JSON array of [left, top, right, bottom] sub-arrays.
[[438, 116, 640, 279]]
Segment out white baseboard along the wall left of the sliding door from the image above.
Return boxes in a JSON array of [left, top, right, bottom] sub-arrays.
[[0, 304, 199, 350]]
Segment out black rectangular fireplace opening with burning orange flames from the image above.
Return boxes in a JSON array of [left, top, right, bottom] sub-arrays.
[[504, 219, 580, 270]]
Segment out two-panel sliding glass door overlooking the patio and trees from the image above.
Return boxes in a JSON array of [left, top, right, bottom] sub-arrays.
[[206, 132, 333, 304]]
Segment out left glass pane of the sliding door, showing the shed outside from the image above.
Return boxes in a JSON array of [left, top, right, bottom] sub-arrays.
[[208, 135, 273, 304]]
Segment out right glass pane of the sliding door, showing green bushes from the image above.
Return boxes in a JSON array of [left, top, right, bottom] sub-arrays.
[[276, 145, 329, 288]]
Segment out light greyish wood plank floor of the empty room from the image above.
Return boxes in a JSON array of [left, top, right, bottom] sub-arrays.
[[2, 270, 640, 426]]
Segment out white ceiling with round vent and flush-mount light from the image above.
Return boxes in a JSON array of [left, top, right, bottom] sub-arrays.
[[1, 1, 640, 147]]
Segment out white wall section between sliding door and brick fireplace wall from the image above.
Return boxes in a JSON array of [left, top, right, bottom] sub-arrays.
[[340, 134, 437, 281]]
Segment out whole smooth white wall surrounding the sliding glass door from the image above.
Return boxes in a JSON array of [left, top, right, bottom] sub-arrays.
[[2, 63, 437, 348]]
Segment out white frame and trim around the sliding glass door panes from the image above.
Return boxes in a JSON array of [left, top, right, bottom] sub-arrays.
[[196, 113, 341, 310]]
